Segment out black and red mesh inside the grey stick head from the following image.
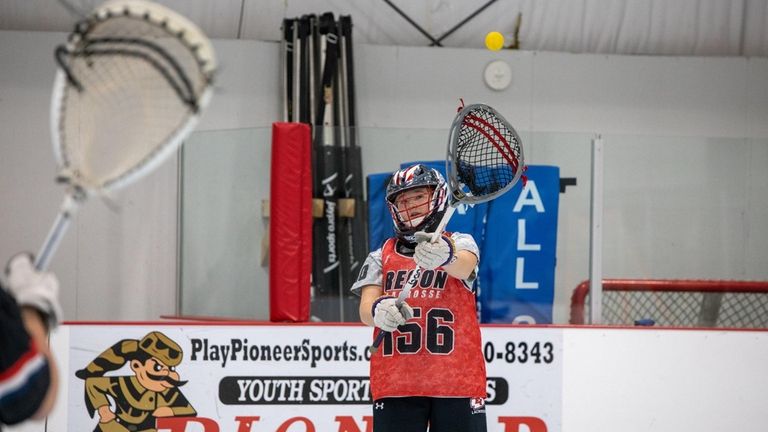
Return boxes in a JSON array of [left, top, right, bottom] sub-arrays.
[[455, 106, 522, 197]]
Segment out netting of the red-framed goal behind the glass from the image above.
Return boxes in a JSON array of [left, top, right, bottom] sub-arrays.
[[584, 290, 768, 328]]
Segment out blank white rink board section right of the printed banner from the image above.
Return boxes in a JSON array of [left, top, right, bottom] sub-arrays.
[[562, 328, 768, 432]]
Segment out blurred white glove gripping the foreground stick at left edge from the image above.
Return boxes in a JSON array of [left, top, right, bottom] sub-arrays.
[[5, 253, 61, 329]]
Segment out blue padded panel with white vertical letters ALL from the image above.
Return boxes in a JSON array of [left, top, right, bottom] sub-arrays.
[[475, 165, 560, 324]]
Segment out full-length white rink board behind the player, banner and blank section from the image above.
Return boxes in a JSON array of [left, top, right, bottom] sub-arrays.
[[36, 322, 768, 432]]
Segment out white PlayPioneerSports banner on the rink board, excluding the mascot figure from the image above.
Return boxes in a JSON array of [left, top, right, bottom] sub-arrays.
[[49, 323, 562, 432]]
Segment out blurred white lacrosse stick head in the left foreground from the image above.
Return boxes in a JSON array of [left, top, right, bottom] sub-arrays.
[[51, 0, 216, 194]]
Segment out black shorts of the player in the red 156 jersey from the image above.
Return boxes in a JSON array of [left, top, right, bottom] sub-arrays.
[[373, 396, 487, 432]]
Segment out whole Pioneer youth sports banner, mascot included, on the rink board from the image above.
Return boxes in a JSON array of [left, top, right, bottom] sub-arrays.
[[64, 324, 563, 432]]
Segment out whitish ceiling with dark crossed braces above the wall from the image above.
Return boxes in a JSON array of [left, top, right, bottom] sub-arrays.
[[0, 0, 768, 57]]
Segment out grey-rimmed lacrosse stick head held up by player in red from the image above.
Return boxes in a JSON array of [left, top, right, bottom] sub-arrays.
[[446, 104, 525, 205]]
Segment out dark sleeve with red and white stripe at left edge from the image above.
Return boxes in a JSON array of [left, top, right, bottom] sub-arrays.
[[0, 286, 51, 424]]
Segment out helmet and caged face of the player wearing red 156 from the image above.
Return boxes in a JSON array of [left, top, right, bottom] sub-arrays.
[[386, 164, 448, 243]]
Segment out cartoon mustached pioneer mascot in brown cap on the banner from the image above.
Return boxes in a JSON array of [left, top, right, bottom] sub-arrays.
[[75, 331, 197, 432]]
